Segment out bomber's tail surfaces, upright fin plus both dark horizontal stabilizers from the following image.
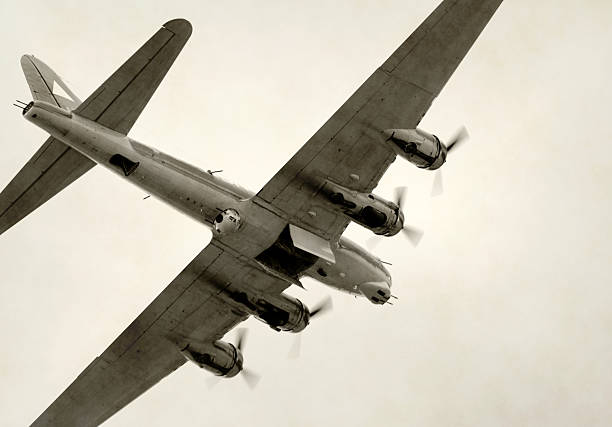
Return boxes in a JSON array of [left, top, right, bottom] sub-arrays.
[[0, 19, 191, 234]]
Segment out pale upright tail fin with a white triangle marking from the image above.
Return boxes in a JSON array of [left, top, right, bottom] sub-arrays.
[[21, 55, 81, 110]]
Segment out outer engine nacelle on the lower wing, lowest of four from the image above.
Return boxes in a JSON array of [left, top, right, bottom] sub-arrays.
[[181, 341, 243, 378]]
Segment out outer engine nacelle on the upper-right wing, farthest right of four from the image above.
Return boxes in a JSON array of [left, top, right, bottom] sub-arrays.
[[383, 129, 447, 170]]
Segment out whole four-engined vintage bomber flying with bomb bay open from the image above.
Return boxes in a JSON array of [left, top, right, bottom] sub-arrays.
[[0, 0, 502, 426]]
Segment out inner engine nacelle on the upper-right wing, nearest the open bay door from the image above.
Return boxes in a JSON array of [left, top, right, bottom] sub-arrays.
[[322, 181, 404, 236]]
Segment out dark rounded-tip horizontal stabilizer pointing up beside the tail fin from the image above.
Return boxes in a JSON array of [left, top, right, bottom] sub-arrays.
[[75, 19, 192, 134]]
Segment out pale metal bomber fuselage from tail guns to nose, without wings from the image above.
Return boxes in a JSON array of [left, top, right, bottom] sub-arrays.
[[24, 101, 391, 304]]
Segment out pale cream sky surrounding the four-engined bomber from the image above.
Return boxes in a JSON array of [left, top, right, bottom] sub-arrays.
[[0, 0, 612, 426]]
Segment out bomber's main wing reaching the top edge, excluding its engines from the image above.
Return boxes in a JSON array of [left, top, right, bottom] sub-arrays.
[[257, 0, 502, 240]]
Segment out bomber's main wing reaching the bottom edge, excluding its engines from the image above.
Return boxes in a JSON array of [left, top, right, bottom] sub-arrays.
[[32, 240, 290, 427]]
